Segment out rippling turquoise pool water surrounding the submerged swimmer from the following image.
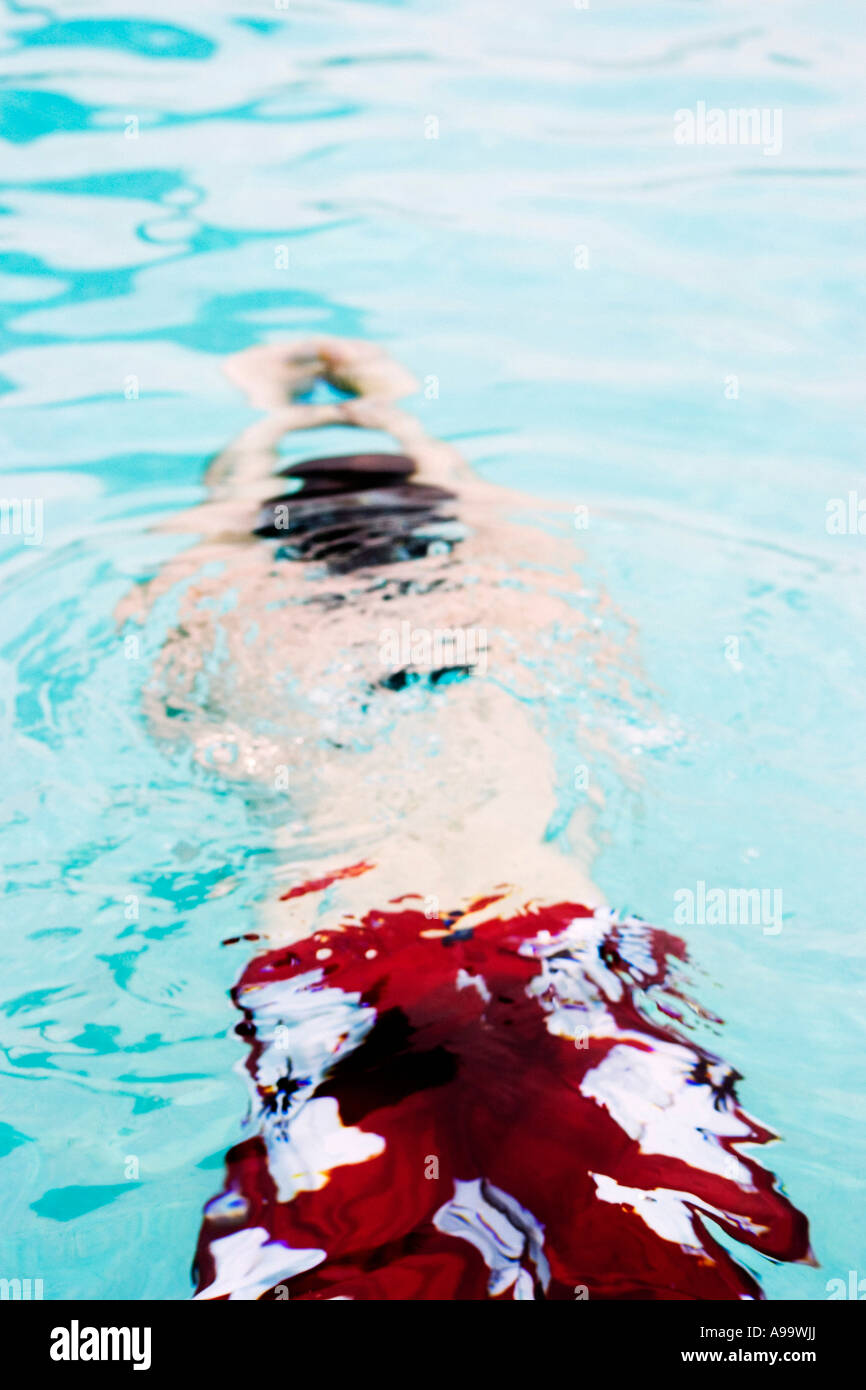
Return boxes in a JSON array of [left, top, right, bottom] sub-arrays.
[[0, 0, 866, 1298]]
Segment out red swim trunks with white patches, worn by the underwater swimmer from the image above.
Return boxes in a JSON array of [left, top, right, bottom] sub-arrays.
[[196, 904, 809, 1301]]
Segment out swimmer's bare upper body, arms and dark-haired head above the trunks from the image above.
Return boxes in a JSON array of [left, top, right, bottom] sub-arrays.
[[118, 338, 627, 930]]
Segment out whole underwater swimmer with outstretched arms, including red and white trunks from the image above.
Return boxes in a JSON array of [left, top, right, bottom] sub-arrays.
[[118, 338, 810, 1300]]
